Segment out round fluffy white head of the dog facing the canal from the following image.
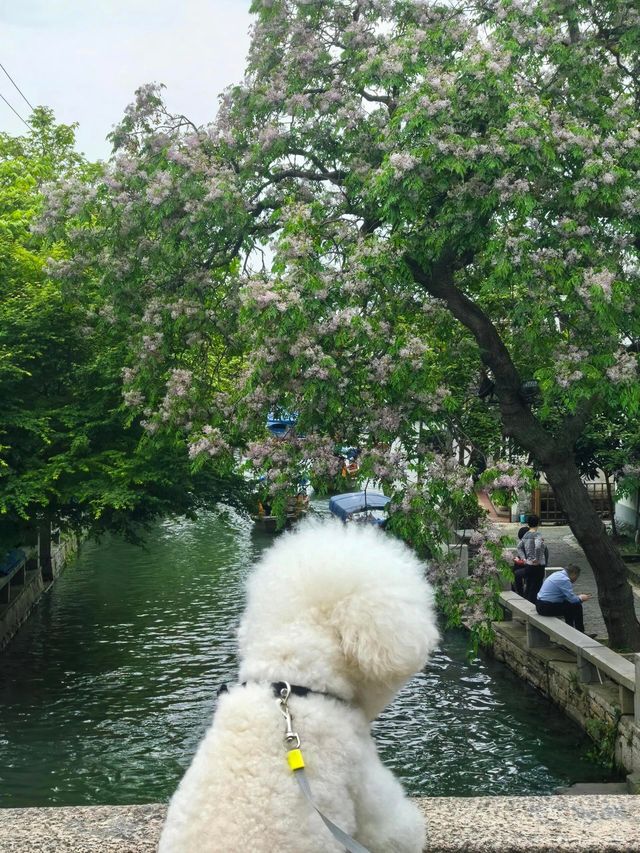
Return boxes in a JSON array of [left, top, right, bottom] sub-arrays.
[[240, 521, 438, 718]]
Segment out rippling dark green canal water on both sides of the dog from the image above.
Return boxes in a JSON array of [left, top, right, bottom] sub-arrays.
[[0, 510, 620, 807]]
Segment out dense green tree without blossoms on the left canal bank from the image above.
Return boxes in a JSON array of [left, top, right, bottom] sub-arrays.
[[0, 108, 250, 560]]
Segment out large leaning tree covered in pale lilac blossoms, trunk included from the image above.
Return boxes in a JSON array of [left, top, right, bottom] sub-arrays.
[[50, 0, 640, 648]]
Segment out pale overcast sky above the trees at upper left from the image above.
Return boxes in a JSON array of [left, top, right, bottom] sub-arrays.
[[0, 0, 251, 159]]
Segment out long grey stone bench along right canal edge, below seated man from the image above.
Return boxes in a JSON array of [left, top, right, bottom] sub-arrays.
[[500, 591, 640, 725]]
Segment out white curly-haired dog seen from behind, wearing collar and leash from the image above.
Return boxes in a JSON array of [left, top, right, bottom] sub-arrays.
[[159, 522, 439, 853]]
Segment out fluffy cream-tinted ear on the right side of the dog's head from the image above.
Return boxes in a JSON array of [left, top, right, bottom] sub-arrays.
[[331, 569, 439, 685]]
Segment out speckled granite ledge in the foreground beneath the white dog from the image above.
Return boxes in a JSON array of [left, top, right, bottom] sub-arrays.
[[0, 795, 640, 853]]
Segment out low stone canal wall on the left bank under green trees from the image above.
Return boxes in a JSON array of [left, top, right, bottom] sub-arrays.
[[0, 534, 79, 652]]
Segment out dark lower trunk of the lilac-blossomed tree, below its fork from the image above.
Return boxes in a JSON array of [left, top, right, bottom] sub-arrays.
[[544, 459, 640, 650]]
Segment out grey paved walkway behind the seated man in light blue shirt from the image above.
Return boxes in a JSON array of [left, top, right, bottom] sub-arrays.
[[498, 524, 640, 639]]
